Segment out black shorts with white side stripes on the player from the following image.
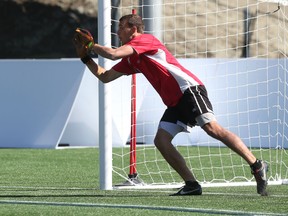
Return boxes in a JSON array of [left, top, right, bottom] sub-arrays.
[[160, 85, 214, 127]]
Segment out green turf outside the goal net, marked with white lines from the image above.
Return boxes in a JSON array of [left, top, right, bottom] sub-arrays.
[[0, 148, 288, 216]]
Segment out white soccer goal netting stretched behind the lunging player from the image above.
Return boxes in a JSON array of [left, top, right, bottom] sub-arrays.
[[99, 0, 288, 188]]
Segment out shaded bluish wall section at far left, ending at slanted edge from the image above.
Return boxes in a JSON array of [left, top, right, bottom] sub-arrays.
[[0, 60, 85, 148]]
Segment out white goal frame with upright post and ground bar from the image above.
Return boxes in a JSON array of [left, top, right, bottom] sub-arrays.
[[98, 0, 288, 190]]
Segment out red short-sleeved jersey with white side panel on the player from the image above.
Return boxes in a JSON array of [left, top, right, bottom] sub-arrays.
[[113, 34, 203, 106]]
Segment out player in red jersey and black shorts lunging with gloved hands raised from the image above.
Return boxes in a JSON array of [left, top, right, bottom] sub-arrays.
[[73, 14, 268, 196]]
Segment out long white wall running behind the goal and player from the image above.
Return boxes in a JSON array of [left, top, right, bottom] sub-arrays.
[[0, 59, 288, 148]]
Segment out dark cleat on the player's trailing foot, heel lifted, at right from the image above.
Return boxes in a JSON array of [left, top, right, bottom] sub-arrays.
[[251, 160, 268, 196]]
